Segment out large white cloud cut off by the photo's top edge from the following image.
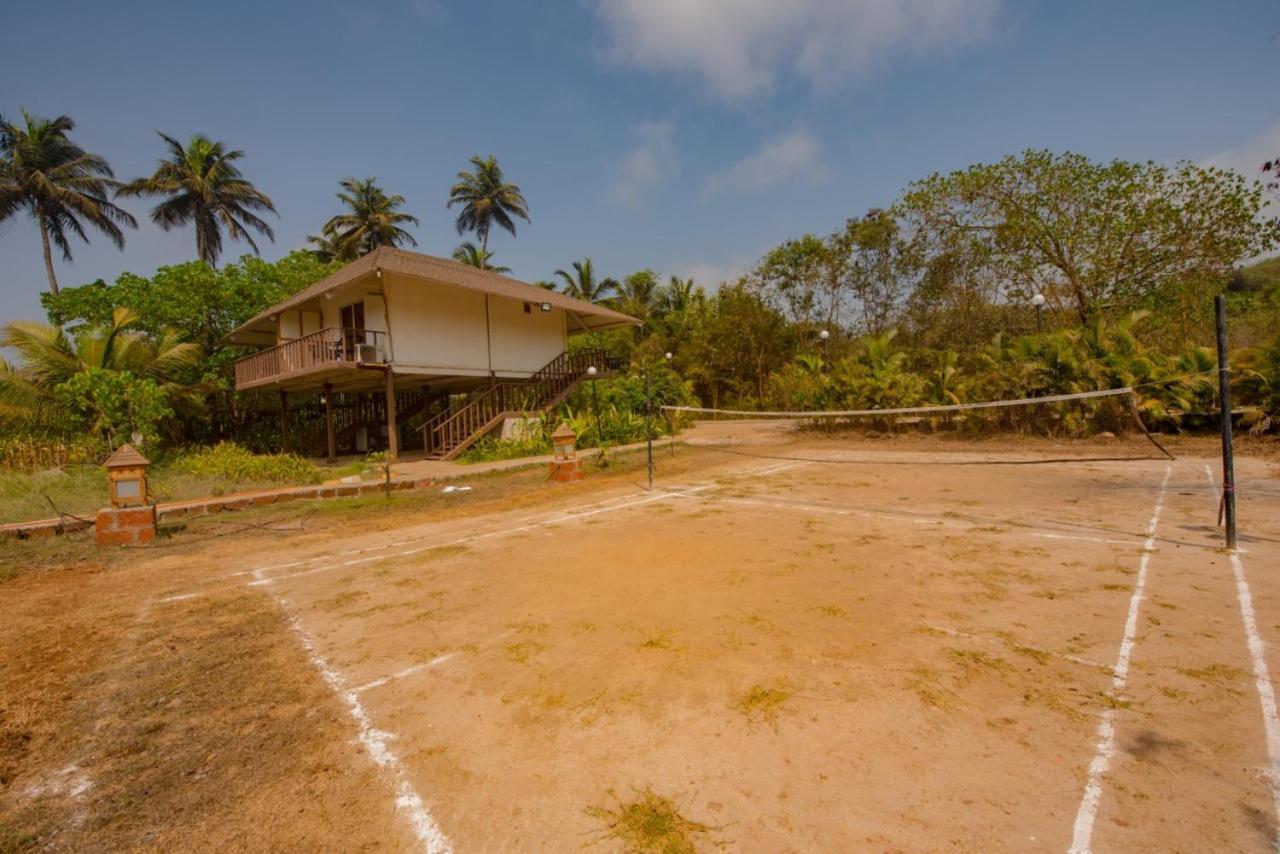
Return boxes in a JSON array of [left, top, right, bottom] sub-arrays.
[[595, 0, 1004, 101]]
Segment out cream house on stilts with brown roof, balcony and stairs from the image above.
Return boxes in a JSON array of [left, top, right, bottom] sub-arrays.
[[228, 247, 640, 460]]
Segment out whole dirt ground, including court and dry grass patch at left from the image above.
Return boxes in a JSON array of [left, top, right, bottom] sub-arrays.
[[0, 424, 1280, 851]]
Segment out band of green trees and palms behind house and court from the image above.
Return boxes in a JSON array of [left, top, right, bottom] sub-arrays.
[[0, 128, 1280, 460]]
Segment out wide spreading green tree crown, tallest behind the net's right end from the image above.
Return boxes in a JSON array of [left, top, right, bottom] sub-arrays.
[[899, 151, 1280, 324]]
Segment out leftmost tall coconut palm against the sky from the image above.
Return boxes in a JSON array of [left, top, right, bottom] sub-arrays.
[[0, 110, 137, 293]]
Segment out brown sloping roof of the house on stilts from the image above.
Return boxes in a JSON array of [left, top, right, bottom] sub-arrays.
[[227, 246, 641, 344]]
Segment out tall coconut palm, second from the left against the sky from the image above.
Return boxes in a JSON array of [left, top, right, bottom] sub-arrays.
[[116, 131, 275, 266]]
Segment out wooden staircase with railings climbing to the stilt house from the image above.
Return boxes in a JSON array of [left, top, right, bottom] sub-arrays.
[[422, 350, 616, 460]]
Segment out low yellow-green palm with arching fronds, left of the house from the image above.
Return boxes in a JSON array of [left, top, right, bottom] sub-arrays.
[[0, 309, 202, 434]]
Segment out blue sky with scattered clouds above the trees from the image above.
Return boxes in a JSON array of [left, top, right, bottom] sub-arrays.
[[0, 0, 1280, 321]]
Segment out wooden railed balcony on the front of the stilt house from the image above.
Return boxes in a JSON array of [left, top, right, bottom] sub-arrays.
[[236, 326, 387, 391]]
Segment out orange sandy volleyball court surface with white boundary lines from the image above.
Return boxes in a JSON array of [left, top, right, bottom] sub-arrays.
[[2, 434, 1280, 851]]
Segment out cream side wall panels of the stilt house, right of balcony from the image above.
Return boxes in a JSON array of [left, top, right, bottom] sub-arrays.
[[384, 273, 564, 376]]
